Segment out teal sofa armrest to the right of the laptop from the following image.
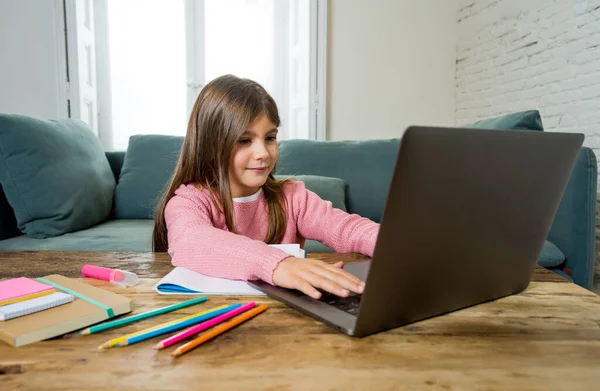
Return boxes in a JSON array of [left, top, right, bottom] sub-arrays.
[[548, 147, 598, 289]]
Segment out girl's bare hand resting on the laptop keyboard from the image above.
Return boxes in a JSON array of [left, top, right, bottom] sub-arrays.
[[273, 257, 365, 299]]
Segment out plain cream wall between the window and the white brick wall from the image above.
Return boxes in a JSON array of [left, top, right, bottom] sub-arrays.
[[326, 0, 458, 140]]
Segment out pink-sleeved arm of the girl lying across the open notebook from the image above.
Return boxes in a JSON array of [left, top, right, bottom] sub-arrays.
[[165, 194, 290, 284]]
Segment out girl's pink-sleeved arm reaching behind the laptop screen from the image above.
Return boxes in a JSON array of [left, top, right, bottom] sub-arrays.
[[292, 182, 379, 256]]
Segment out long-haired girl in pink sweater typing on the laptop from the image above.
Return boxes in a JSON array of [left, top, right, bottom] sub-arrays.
[[153, 75, 379, 299]]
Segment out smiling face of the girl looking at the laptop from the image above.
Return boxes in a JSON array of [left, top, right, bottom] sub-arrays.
[[229, 114, 279, 198]]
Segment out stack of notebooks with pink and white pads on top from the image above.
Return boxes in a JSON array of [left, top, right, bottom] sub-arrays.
[[0, 275, 131, 346]]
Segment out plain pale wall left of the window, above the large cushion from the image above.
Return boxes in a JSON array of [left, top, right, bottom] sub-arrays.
[[0, 0, 66, 118]]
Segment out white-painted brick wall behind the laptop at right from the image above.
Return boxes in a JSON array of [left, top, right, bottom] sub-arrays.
[[456, 0, 600, 293]]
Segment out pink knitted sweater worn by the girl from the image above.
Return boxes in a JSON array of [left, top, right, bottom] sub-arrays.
[[165, 182, 379, 284]]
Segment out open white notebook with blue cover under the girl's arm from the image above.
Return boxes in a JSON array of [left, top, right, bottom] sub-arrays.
[[154, 244, 305, 295]]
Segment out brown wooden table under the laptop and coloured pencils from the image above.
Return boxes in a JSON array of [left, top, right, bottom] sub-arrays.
[[0, 252, 600, 391]]
